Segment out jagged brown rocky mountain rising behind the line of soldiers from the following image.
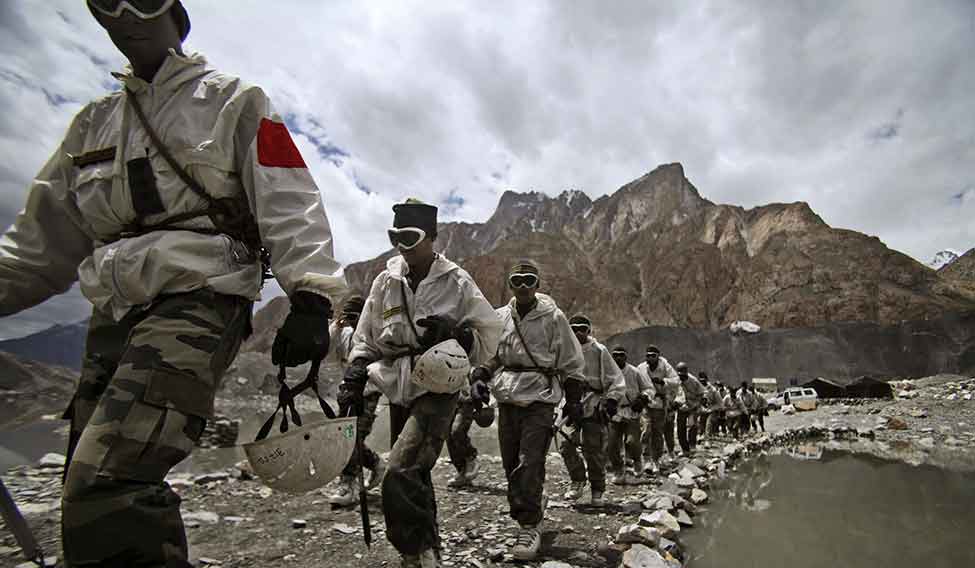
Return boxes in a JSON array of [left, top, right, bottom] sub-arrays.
[[346, 164, 975, 336]]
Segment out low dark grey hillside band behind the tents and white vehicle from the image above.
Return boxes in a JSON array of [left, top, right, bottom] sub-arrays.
[[605, 312, 975, 384]]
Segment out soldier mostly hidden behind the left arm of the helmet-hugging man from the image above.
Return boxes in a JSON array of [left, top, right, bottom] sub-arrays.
[[328, 296, 386, 507]]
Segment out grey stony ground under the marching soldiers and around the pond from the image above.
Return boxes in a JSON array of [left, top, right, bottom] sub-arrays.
[[0, 376, 975, 568]]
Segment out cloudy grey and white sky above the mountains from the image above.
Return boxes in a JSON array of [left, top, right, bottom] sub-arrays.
[[0, 0, 975, 338]]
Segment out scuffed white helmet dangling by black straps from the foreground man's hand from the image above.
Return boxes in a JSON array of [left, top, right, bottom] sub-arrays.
[[244, 416, 356, 493]]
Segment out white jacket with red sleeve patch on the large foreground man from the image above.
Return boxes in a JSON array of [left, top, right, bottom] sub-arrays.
[[0, 52, 346, 319]]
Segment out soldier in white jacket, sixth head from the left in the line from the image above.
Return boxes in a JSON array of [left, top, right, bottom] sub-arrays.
[[607, 345, 655, 485]]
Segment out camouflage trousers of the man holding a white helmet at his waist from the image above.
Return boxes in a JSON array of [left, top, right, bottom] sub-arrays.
[[382, 393, 457, 555]]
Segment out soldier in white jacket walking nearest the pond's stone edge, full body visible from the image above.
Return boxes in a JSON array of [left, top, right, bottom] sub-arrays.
[[471, 260, 585, 560]]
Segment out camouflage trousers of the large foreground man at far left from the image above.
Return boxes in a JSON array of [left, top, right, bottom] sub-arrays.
[[61, 290, 251, 568]]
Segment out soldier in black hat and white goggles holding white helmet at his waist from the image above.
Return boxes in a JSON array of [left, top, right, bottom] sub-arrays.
[[339, 199, 501, 568]]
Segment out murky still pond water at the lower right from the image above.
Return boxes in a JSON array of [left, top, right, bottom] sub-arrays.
[[686, 446, 975, 568]]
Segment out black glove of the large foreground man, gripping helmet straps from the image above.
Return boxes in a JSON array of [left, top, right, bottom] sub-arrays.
[[271, 291, 332, 367]]
